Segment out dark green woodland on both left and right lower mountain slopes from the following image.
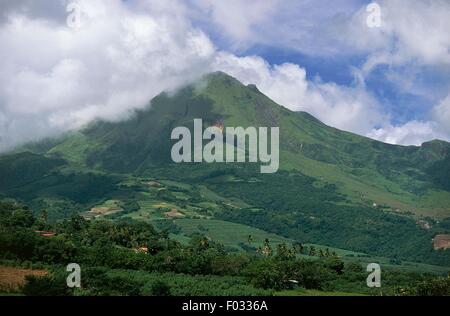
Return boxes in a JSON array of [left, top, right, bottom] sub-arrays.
[[3, 148, 450, 266]]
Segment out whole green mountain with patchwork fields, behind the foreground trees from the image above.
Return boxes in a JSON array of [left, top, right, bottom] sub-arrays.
[[0, 72, 450, 265]]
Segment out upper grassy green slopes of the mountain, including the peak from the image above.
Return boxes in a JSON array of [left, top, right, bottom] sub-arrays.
[[43, 73, 450, 218]]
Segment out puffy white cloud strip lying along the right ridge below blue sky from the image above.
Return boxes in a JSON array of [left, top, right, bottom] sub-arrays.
[[213, 52, 450, 146]]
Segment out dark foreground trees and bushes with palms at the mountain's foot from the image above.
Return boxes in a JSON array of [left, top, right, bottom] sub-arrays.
[[0, 203, 450, 295]]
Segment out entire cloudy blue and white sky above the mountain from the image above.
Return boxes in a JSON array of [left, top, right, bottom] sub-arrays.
[[0, 0, 450, 151]]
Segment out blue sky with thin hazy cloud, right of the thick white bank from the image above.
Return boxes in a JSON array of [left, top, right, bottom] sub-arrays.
[[188, 0, 450, 145]]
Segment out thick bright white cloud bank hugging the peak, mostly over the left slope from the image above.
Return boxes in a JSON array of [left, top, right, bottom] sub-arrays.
[[0, 0, 382, 149]]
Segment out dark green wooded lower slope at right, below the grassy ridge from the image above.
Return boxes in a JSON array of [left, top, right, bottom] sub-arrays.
[[207, 169, 450, 265]]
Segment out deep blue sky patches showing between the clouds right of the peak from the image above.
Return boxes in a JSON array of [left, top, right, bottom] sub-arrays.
[[201, 0, 450, 128]]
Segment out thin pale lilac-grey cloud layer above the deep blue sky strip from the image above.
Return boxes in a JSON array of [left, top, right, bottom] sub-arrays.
[[195, 0, 450, 67]]
